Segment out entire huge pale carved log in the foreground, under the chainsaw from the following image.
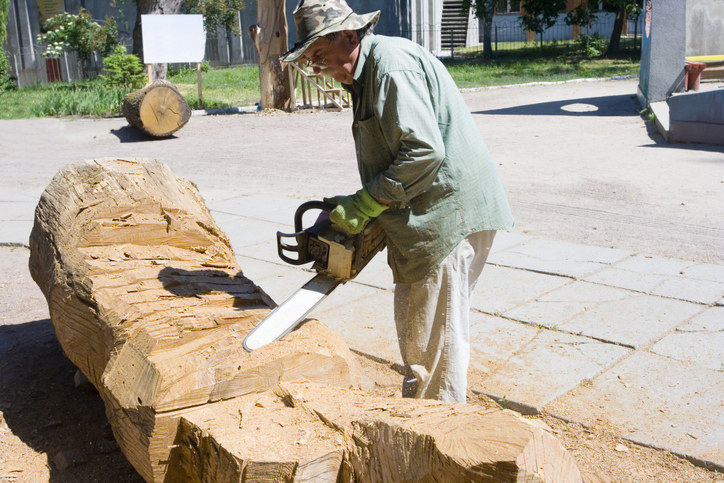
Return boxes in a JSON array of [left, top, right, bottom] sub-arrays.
[[30, 159, 580, 483]]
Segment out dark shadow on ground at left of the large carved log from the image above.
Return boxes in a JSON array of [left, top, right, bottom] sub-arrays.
[[0, 319, 143, 483]]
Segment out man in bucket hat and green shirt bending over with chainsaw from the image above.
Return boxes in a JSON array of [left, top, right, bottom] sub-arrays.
[[281, 0, 513, 403]]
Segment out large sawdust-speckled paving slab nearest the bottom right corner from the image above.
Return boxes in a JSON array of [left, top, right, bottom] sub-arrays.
[[546, 351, 724, 468]]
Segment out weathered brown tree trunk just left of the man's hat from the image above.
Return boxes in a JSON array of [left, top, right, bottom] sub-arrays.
[[249, 0, 292, 110]]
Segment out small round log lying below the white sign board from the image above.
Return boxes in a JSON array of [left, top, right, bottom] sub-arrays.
[[121, 79, 191, 137]]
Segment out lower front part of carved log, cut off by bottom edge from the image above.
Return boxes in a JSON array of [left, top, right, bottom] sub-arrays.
[[169, 382, 581, 483]]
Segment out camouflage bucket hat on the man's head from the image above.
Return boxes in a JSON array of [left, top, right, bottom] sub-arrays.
[[279, 0, 380, 62]]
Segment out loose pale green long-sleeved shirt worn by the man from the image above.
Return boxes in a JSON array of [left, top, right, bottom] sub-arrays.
[[346, 34, 513, 283]]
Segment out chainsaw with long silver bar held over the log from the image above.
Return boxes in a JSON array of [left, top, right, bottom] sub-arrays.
[[242, 201, 385, 352]]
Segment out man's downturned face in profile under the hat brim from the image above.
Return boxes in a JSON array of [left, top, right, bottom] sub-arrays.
[[304, 30, 359, 84]]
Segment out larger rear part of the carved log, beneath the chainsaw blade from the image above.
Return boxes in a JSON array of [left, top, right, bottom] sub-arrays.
[[30, 159, 355, 481]]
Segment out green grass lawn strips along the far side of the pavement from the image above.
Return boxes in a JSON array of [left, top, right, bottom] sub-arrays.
[[0, 45, 639, 119]]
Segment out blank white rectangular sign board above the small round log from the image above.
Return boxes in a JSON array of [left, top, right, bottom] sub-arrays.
[[141, 15, 206, 64]]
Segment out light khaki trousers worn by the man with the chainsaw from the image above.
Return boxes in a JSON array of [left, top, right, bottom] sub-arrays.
[[394, 230, 495, 403]]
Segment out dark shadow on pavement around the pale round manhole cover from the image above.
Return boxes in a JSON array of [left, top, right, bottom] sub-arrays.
[[473, 94, 640, 117]]
